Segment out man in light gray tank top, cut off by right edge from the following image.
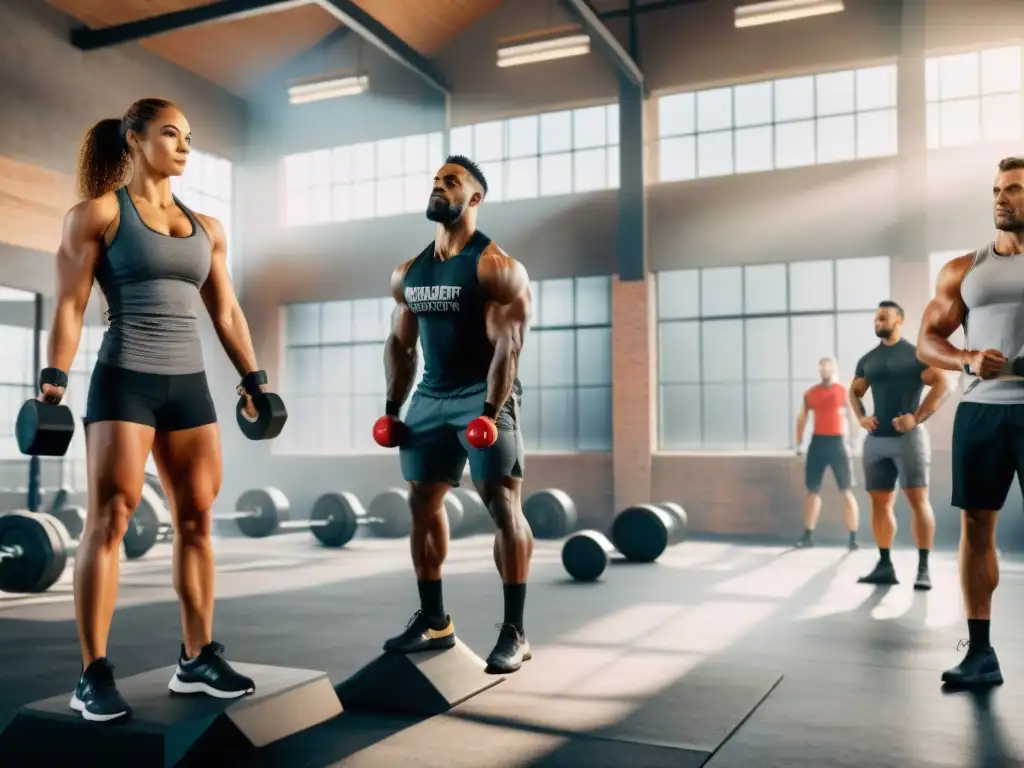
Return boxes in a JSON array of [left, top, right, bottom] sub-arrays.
[[918, 157, 1024, 686]]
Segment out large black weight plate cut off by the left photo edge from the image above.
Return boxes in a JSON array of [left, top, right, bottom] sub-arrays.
[[0, 510, 69, 594]]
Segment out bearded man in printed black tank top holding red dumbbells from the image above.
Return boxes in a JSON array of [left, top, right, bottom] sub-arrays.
[[374, 156, 534, 674]]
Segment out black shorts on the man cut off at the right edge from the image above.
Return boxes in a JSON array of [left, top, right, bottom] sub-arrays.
[[952, 402, 1024, 509]]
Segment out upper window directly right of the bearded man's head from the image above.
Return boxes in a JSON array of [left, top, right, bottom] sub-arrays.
[[451, 103, 618, 201]]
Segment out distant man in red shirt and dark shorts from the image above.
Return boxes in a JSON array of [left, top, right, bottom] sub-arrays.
[[797, 357, 860, 550]]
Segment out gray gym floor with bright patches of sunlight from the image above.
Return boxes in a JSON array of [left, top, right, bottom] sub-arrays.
[[0, 535, 1024, 768]]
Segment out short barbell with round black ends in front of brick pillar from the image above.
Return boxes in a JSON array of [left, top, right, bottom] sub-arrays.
[[562, 502, 687, 582]]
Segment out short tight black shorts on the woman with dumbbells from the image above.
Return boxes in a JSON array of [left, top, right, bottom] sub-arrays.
[[83, 362, 217, 432]]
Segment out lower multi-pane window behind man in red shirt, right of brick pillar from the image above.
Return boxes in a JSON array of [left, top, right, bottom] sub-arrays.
[[657, 256, 891, 451]]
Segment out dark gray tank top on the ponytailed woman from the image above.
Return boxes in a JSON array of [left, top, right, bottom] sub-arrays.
[[96, 187, 213, 375]]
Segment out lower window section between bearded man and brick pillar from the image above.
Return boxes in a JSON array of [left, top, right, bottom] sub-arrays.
[[519, 276, 611, 452]]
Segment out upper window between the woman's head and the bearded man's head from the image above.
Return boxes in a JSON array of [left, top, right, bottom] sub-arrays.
[[285, 132, 444, 226]]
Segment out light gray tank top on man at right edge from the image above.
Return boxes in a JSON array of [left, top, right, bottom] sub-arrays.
[[961, 243, 1024, 406]]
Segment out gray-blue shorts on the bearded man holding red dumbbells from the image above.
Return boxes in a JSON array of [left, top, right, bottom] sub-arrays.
[[398, 392, 525, 486]]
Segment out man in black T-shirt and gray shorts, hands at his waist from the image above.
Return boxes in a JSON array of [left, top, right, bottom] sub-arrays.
[[850, 301, 949, 590]]
